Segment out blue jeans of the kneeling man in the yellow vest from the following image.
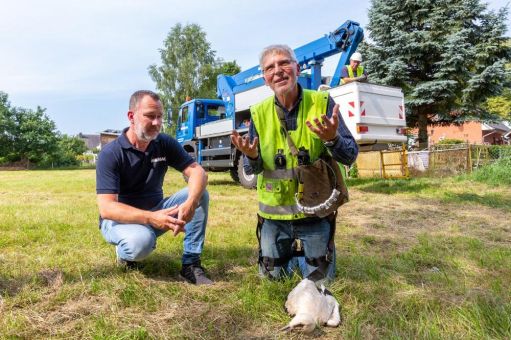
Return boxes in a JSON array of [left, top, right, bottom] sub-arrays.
[[259, 218, 335, 283]]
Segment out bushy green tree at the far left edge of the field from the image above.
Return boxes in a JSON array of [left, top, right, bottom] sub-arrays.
[[0, 92, 58, 167]]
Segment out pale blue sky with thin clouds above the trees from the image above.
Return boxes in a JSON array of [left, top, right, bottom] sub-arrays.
[[0, 0, 511, 135]]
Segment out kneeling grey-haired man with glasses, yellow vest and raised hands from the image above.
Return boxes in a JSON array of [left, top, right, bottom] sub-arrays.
[[231, 45, 358, 282]]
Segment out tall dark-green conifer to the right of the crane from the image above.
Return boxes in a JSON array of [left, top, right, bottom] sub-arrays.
[[360, 0, 511, 147]]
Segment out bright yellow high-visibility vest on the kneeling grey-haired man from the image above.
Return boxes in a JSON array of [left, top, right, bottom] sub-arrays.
[[250, 90, 328, 220]]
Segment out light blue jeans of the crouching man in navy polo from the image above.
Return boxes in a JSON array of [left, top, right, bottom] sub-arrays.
[[101, 188, 209, 264]]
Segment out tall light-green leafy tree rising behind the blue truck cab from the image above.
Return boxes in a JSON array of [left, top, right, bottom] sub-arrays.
[[149, 23, 240, 134]]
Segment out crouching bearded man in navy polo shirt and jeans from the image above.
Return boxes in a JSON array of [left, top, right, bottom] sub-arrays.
[[96, 91, 213, 284]]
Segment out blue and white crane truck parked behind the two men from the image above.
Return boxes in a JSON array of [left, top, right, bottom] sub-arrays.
[[169, 20, 406, 188]]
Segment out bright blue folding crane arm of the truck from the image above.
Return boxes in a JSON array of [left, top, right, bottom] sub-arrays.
[[217, 20, 364, 116]]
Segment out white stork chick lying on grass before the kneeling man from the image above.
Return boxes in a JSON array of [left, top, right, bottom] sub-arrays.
[[281, 279, 341, 333]]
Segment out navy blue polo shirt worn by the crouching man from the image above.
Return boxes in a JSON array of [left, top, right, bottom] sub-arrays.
[[96, 128, 194, 210]]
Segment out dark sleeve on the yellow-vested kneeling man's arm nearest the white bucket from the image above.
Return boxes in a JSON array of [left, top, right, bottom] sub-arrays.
[[327, 96, 358, 165]]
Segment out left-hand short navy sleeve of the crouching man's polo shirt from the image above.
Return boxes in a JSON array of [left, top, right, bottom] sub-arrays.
[[96, 148, 121, 194]]
